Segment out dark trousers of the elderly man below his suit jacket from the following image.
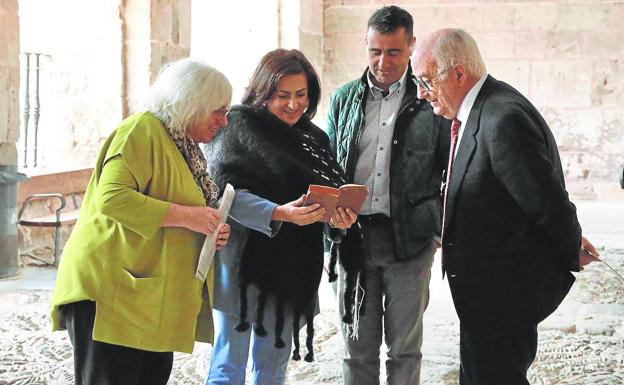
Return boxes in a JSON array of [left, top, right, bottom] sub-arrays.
[[459, 326, 537, 385]]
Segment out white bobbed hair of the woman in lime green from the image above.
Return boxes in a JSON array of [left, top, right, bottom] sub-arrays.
[[144, 58, 232, 134]]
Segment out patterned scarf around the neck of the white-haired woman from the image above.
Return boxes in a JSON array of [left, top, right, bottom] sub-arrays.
[[164, 125, 219, 207]]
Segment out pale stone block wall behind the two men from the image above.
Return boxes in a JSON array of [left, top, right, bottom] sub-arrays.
[[323, 0, 624, 195]]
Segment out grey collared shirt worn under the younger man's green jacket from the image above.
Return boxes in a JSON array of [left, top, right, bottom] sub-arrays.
[[354, 68, 407, 216]]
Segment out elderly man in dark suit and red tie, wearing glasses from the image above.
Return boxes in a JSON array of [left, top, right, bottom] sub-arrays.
[[412, 29, 596, 385]]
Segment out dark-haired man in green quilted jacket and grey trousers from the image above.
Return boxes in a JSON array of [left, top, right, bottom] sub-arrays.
[[327, 6, 450, 385]]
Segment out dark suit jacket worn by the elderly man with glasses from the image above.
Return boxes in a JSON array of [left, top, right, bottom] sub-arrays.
[[443, 76, 581, 335]]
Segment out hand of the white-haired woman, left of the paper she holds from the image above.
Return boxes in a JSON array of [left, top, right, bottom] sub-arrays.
[[162, 203, 222, 234]]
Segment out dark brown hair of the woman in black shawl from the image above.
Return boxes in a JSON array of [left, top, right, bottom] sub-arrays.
[[241, 48, 321, 119]]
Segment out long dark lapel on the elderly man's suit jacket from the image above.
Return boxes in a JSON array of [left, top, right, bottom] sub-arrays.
[[444, 75, 496, 230]]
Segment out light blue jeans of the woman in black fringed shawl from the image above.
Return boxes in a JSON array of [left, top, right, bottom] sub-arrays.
[[206, 306, 293, 385]]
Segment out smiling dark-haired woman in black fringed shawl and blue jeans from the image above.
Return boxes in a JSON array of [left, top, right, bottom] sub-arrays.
[[205, 49, 362, 385]]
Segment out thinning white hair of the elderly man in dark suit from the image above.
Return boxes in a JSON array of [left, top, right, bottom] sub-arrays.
[[431, 28, 486, 78]]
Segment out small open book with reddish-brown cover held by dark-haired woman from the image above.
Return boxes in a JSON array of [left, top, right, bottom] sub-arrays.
[[303, 184, 368, 222]]
